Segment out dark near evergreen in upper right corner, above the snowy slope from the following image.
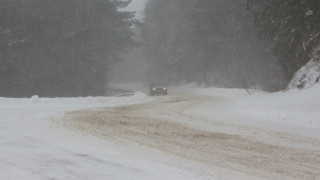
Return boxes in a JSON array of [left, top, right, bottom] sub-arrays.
[[247, 0, 320, 79]]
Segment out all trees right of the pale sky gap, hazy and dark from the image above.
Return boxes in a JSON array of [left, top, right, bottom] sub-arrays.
[[142, 0, 320, 91]]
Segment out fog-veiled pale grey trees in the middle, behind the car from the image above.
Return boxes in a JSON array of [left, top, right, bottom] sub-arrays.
[[111, 0, 287, 91]]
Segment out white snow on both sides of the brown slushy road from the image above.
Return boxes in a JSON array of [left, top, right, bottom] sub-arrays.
[[0, 85, 320, 179]]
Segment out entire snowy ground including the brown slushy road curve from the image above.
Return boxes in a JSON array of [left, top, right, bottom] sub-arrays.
[[0, 85, 320, 179]]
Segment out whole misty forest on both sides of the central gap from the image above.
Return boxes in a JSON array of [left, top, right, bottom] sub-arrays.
[[0, 0, 320, 97]]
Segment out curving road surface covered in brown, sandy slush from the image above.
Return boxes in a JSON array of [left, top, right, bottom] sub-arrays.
[[59, 94, 320, 179]]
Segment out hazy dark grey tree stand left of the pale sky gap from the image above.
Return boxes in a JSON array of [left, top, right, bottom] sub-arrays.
[[0, 0, 136, 97]]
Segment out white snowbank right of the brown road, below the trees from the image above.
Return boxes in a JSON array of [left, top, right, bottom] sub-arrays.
[[186, 84, 320, 129]]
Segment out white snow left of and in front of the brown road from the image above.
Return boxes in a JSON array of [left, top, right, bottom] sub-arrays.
[[0, 92, 198, 180]]
